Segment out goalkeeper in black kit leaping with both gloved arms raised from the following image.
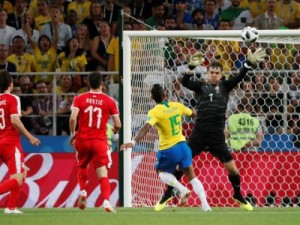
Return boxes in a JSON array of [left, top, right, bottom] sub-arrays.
[[157, 48, 266, 211]]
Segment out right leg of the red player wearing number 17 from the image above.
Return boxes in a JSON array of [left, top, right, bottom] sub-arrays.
[[93, 140, 115, 212]]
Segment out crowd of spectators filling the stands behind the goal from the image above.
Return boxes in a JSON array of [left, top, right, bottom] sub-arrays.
[[0, 0, 300, 142]]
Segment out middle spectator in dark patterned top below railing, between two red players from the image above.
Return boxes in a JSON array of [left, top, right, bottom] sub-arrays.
[[31, 80, 53, 135]]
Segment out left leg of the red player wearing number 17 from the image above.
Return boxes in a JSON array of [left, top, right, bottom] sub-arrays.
[[75, 141, 91, 210]]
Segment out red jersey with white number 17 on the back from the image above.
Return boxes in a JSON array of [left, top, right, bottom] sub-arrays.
[[72, 92, 120, 140]]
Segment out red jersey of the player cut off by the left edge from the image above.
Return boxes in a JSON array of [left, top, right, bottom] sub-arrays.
[[0, 93, 21, 144]]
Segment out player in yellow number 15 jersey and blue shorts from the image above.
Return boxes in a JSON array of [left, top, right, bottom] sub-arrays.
[[121, 84, 211, 211]]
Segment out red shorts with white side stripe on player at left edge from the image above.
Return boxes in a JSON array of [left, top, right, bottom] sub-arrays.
[[0, 143, 24, 175]]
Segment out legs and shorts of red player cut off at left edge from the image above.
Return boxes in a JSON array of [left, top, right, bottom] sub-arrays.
[[0, 144, 26, 214]]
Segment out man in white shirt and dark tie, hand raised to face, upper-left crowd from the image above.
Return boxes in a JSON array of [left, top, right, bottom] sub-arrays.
[[41, 6, 72, 53]]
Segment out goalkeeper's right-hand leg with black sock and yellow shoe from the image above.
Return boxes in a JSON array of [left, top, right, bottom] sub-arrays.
[[210, 143, 253, 211]]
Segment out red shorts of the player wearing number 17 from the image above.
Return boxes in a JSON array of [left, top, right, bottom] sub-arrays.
[[75, 139, 112, 169]]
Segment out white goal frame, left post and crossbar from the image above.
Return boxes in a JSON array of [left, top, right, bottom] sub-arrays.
[[120, 30, 300, 207]]
